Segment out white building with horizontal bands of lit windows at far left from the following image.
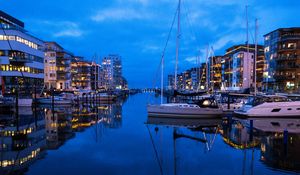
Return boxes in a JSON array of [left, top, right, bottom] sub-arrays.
[[0, 11, 44, 96]]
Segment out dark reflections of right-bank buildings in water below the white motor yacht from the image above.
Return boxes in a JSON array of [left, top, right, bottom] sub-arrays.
[[221, 119, 300, 172]]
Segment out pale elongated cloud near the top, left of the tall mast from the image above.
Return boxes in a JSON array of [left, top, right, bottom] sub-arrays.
[[91, 8, 150, 22]]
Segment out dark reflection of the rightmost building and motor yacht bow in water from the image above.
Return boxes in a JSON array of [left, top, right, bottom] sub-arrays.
[[254, 119, 300, 172]]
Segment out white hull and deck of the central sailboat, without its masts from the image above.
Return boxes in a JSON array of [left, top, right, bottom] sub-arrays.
[[147, 98, 223, 118]]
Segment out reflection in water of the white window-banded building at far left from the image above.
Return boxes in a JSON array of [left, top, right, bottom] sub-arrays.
[[0, 107, 46, 174]]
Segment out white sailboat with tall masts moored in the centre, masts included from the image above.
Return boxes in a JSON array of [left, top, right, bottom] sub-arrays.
[[147, 0, 223, 118]]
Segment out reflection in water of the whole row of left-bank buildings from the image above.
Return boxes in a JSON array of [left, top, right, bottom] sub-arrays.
[[0, 99, 122, 175]]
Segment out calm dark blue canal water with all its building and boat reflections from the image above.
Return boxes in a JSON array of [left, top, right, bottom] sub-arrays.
[[0, 94, 300, 175]]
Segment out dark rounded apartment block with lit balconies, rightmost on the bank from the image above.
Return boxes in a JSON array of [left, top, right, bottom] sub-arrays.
[[264, 28, 300, 93]]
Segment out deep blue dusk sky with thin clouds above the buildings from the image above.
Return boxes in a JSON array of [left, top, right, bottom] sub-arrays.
[[0, 0, 300, 87]]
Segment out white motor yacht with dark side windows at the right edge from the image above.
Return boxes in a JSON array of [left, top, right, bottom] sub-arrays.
[[234, 95, 300, 118]]
